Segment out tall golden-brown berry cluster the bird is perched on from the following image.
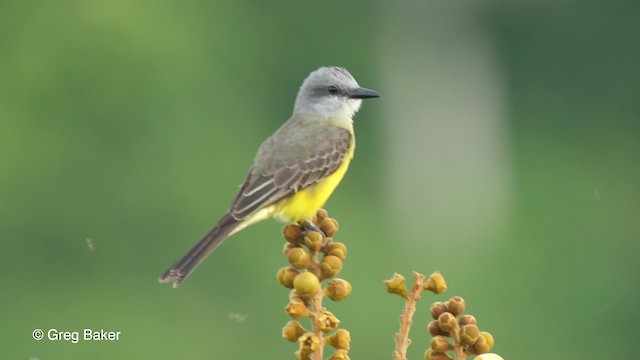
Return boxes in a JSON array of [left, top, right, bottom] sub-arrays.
[[278, 209, 351, 360]]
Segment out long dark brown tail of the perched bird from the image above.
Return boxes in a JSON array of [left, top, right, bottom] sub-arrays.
[[160, 213, 242, 287]]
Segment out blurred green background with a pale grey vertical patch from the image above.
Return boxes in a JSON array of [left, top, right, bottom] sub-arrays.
[[0, 0, 640, 360]]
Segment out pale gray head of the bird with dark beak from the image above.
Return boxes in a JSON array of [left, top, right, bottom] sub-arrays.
[[294, 66, 380, 119]]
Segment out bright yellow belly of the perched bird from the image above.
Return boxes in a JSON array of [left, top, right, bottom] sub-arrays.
[[273, 145, 353, 222]]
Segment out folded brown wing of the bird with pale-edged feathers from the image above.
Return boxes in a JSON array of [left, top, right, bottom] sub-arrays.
[[229, 127, 351, 220]]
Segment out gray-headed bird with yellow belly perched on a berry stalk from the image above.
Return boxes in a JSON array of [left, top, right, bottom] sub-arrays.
[[159, 66, 381, 287]]
